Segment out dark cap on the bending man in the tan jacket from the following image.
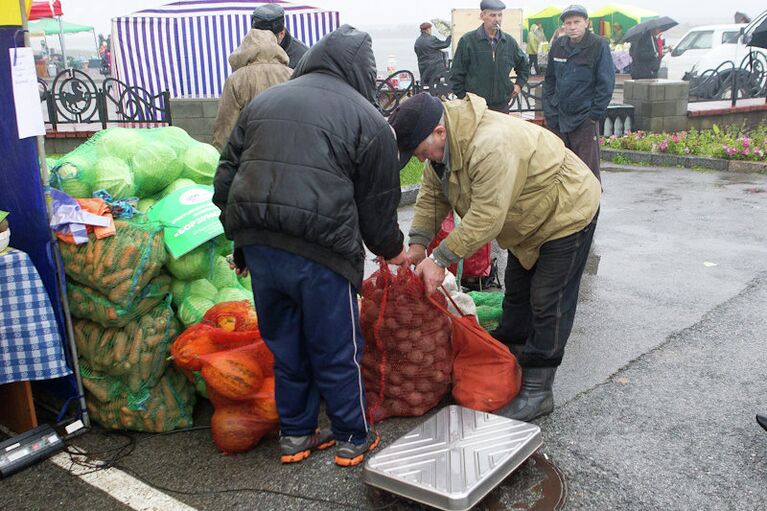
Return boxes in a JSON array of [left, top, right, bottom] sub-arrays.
[[389, 92, 445, 168]]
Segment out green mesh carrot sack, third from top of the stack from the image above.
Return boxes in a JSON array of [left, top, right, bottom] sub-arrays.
[[74, 303, 181, 394]]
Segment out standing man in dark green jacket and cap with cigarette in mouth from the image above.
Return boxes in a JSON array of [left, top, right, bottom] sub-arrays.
[[450, 0, 530, 113]]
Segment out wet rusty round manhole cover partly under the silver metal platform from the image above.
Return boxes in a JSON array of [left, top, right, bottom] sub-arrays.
[[367, 451, 567, 511]]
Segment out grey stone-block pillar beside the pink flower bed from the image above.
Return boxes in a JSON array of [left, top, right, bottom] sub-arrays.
[[623, 80, 690, 133]]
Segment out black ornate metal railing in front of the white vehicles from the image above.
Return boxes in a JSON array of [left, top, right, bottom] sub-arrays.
[[685, 51, 767, 106]]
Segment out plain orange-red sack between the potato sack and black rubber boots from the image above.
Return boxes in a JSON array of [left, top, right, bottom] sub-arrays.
[[432, 292, 522, 412]]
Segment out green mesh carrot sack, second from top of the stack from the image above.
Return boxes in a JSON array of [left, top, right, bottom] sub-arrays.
[[67, 274, 170, 327]]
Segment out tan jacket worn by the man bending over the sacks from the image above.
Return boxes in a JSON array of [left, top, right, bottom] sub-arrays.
[[409, 94, 601, 269]]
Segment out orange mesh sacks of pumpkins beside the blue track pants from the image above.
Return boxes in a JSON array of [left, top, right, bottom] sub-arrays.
[[171, 300, 279, 454]]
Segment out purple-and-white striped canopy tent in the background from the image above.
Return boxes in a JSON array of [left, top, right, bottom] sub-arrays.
[[112, 0, 340, 98]]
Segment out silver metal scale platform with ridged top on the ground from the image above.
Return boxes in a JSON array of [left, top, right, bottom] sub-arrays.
[[363, 405, 543, 511]]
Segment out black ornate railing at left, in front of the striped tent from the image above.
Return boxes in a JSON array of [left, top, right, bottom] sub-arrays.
[[38, 69, 171, 129]]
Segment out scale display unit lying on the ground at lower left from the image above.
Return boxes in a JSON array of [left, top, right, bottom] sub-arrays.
[[0, 424, 64, 478]]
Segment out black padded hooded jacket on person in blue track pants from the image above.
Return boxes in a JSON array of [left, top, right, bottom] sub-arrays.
[[213, 25, 403, 290]]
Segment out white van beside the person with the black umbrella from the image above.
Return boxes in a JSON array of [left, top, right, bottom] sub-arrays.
[[658, 24, 746, 80]]
